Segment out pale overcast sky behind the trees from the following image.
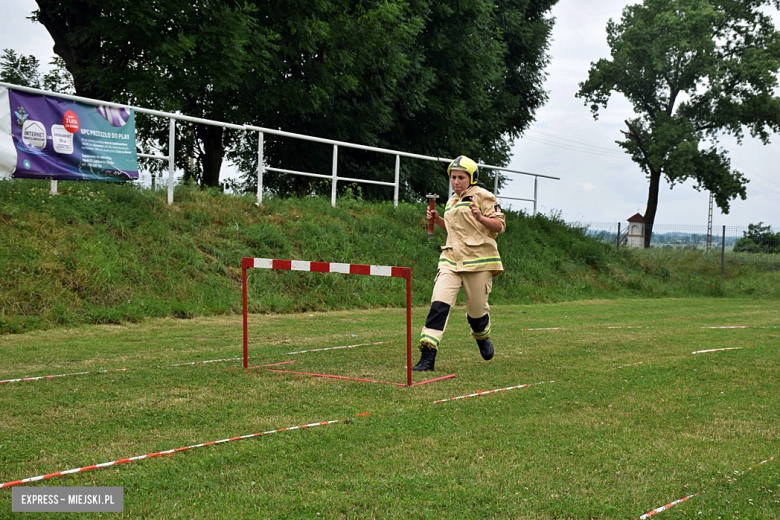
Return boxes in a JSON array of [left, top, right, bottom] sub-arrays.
[[0, 0, 780, 229]]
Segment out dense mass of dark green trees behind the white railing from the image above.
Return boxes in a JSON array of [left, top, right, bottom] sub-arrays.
[[29, 0, 557, 198]]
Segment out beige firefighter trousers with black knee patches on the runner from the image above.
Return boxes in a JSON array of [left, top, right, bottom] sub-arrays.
[[420, 270, 493, 348]]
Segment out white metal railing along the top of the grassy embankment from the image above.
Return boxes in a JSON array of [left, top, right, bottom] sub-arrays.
[[0, 82, 560, 210]]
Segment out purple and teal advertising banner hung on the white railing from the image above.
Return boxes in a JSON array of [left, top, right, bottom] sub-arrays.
[[0, 87, 138, 181]]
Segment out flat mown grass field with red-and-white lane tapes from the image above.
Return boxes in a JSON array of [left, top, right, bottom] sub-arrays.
[[0, 298, 780, 520]]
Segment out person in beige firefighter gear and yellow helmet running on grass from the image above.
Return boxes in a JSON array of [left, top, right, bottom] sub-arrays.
[[412, 155, 506, 372]]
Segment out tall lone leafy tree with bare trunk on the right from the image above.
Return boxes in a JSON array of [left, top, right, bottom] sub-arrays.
[[576, 0, 780, 246]]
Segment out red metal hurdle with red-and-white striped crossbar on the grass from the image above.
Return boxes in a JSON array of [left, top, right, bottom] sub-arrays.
[[241, 258, 454, 386]]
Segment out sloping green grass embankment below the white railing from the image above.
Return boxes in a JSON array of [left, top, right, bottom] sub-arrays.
[[0, 181, 780, 333]]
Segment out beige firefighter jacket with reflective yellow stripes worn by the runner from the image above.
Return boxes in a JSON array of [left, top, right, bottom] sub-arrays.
[[439, 186, 506, 276]]
